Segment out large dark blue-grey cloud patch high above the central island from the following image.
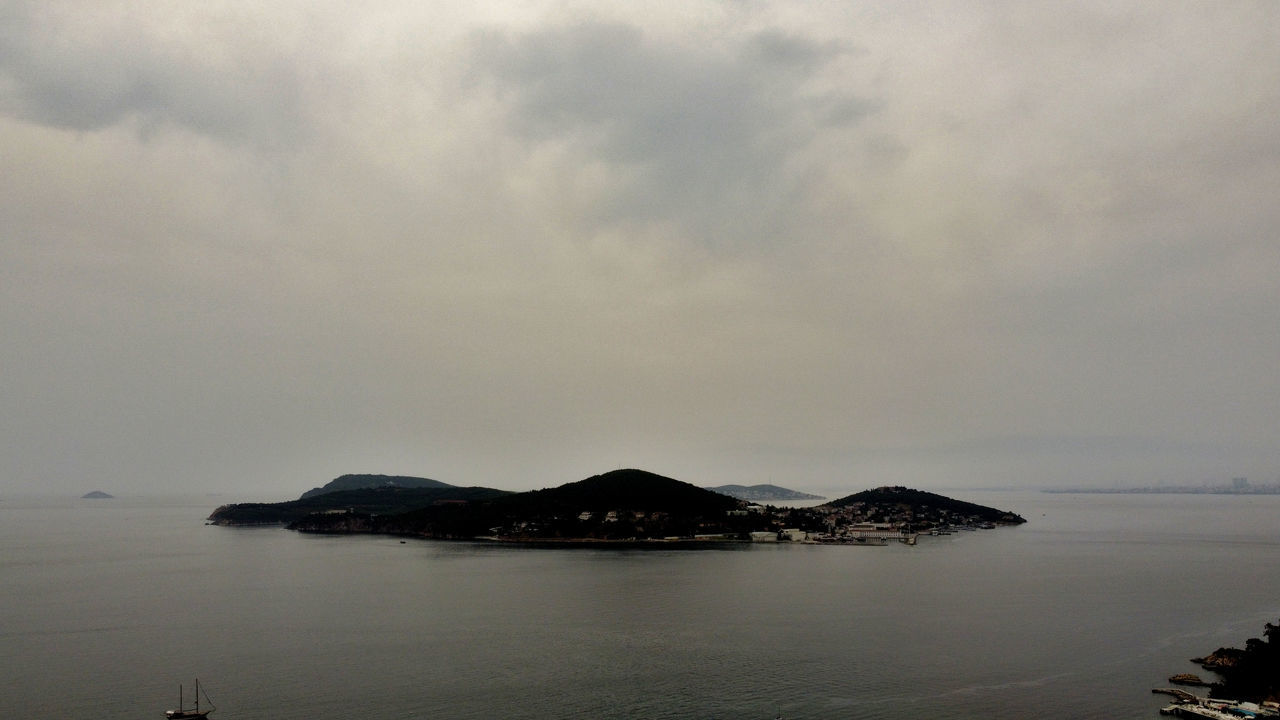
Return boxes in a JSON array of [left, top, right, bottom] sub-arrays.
[[472, 23, 874, 245]]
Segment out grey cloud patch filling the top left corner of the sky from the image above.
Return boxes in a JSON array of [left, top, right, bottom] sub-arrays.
[[0, 1, 306, 145]]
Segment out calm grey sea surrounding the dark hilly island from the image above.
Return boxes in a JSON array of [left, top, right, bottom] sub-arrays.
[[0, 491, 1280, 720]]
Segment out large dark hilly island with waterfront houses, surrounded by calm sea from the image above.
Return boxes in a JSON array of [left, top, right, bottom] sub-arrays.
[[209, 469, 1025, 544]]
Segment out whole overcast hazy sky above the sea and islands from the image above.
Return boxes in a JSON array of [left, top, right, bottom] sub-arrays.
[[0, 0, 1280, 498]]
